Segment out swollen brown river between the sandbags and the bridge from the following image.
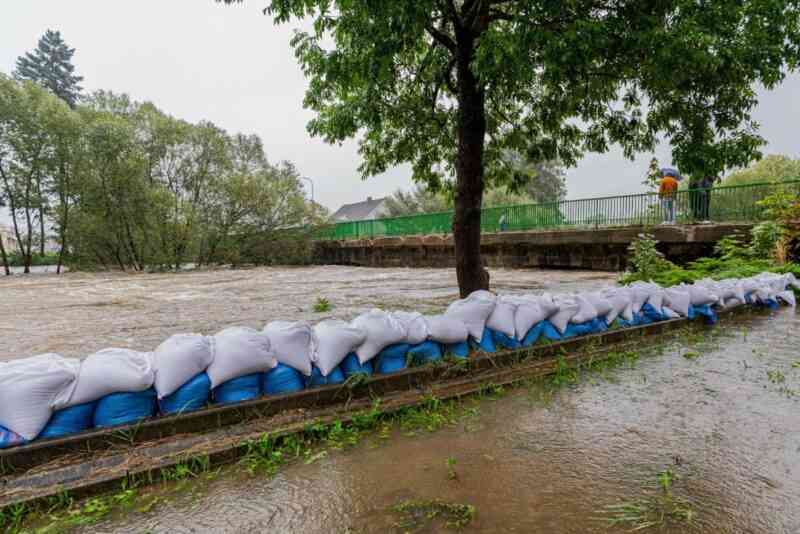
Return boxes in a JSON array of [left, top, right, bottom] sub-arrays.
[[0, 266, 616, 361]]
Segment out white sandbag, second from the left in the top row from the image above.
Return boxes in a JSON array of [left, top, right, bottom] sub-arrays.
[[67, 348, 155, 407]]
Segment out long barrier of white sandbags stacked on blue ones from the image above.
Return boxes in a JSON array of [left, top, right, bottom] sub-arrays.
[[0, 273, 800, 448]]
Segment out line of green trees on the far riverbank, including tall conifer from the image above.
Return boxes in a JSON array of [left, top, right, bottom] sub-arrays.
[[0, 31, 326, 273]]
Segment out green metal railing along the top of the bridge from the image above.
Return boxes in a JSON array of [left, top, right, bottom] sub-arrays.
[[318, 180, 800, 239]]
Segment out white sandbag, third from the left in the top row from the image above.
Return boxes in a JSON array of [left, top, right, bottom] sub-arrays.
[[152, 334, 214, 399]]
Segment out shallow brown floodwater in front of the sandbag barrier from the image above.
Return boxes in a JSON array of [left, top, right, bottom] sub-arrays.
[[87, 309, 800, 534]]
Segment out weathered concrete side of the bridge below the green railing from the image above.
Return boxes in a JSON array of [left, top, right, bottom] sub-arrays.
[[315, 224, 751, 271]]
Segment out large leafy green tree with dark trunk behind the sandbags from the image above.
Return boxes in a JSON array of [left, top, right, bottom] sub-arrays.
[[219, 0, 798, 294]]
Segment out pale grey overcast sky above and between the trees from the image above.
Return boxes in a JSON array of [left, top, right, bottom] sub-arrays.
[[0, 0, 800, 215]]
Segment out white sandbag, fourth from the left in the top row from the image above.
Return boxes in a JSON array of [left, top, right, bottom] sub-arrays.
[[206, 326, 278, 388]]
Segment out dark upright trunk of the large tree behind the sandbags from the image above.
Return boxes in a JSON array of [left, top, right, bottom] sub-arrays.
[[453, 36, 489, 298]]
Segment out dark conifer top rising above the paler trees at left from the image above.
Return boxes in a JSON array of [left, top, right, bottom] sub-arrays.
[[14, 30, 83, 108]]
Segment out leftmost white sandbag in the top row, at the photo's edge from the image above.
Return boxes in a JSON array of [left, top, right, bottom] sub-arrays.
[[0, 354, 80, 440]]
